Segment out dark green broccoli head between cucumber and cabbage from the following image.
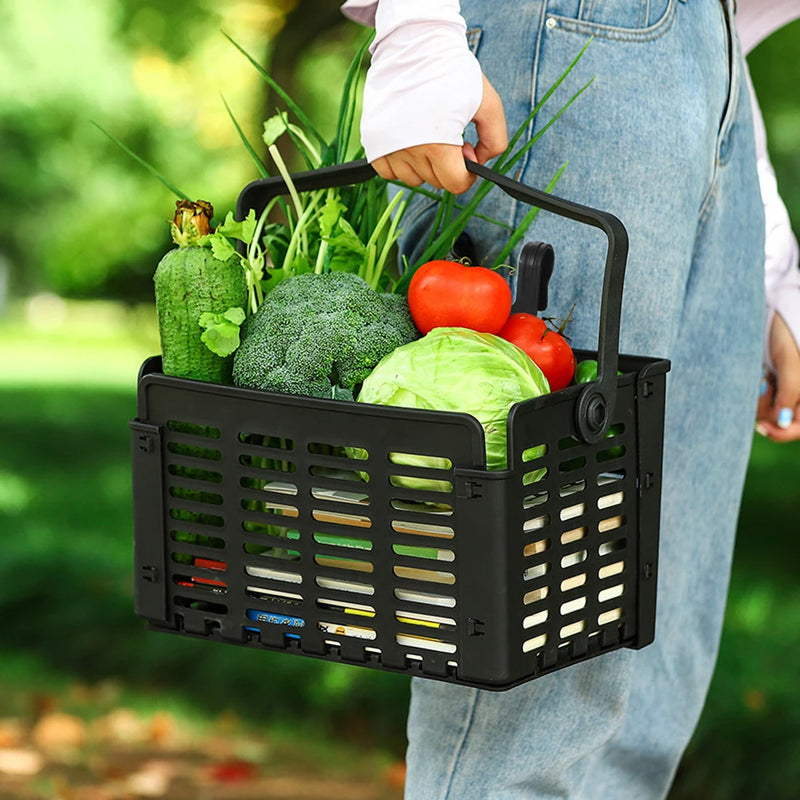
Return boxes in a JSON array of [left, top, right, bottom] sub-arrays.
[[233, 272, 420, 399]]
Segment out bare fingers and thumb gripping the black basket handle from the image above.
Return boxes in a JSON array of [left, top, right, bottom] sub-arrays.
[[372, 75, 508, 194]]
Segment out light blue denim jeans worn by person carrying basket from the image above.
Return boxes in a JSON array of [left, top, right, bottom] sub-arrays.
[[406, 0, 764, 800]]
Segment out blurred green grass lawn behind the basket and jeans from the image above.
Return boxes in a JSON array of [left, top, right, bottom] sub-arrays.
[[0, 304, 800, 800]]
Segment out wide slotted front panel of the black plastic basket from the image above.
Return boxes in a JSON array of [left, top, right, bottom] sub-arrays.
[[131, 375, 496, 679]]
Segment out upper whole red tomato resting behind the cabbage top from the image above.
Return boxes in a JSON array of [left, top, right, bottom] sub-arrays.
[[408, 261, 511, 333]]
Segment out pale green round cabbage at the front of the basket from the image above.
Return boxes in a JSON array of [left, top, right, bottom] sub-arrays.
[[358, 328, 550, 482]]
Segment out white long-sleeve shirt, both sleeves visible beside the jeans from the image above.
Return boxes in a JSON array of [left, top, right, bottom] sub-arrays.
[[342, 0, 800, 367]]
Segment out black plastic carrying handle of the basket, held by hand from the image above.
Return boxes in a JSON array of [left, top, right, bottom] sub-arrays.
[[236, 159, 628, 444]]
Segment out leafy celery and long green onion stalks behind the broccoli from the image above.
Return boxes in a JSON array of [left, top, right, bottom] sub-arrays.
[[97, 29, 591, 316]]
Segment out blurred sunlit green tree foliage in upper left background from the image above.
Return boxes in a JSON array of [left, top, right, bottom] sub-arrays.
[[0, 0, 357, 300]]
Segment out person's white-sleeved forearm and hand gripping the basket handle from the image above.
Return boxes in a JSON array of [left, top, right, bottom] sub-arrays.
[[342, 0, 508, 194]]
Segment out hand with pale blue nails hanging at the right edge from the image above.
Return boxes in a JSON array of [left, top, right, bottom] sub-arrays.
[[756, 314, 800, 442]]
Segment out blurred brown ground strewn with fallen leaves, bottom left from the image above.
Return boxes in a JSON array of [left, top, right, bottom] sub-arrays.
[[0, 698, 403, 800]]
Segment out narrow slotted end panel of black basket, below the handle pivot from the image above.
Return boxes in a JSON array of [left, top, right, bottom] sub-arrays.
[[510, 359, 664, 675]]
